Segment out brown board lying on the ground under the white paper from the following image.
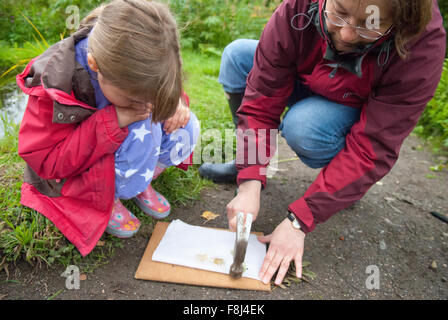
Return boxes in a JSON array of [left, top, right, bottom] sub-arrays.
[[135, 221, 271, 291]]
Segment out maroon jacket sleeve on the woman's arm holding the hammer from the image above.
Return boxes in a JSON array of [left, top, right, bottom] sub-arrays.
[[236, 0, 307, 187]]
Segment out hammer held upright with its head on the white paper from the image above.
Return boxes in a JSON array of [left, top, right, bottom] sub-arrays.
[[230, 212, 253, 279]]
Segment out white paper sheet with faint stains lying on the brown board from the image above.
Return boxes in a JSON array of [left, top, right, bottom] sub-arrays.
[[152, 219, 266, 280]]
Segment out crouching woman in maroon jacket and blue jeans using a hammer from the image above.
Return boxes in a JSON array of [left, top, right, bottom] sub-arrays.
[[200, 0, 446, 284]]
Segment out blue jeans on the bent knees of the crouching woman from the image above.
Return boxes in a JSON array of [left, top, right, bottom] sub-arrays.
[[218, 39, 361, 169]]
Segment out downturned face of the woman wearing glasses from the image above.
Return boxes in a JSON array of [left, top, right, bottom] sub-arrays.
[[324, 0, 392, 52]]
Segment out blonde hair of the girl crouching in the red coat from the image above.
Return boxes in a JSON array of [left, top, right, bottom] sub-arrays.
[[80, 0, 182, 122]]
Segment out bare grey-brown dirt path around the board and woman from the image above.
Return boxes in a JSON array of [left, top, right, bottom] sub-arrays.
[[0, 136, 448, 300]]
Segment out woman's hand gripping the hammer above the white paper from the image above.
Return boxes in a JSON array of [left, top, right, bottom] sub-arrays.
[[226, 180, 261, 231]]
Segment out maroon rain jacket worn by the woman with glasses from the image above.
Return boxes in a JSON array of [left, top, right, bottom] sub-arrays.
[[237, 0, 446, 233]]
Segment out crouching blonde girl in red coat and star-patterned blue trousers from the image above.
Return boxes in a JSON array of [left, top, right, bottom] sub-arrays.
[[17, 0, 199, 256]]
